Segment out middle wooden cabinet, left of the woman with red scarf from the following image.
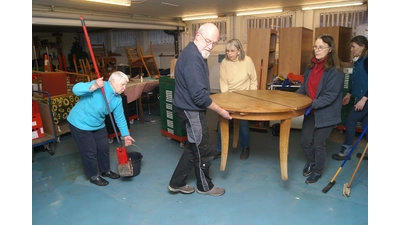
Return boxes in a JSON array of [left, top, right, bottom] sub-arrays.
[[278, 27, 314, 75]]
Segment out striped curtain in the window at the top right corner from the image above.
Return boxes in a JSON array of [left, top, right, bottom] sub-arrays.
[[319, 10, 368, 36]]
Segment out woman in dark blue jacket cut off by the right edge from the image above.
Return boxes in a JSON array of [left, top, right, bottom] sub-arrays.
[[332, 35, 368, 160]]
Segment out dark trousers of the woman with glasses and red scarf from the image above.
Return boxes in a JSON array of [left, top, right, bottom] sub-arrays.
[[301, 113, 335, 174]]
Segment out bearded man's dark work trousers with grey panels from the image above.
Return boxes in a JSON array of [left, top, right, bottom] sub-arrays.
[[169, 107, 215, 191]]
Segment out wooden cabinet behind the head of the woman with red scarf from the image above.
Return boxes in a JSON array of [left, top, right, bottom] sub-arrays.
[[315, 26, 352, 62]]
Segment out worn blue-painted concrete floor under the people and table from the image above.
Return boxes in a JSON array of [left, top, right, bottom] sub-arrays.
[[32, 106, 368, 225]]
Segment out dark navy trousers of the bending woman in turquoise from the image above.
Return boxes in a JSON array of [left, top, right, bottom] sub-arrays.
[[69, 123, 110, 177]]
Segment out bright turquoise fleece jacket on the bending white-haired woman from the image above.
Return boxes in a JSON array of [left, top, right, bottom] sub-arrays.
[[67, 80, 129, 136]]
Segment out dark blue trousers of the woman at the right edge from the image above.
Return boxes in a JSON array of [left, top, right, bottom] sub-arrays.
[[343, 101, 368, 145]]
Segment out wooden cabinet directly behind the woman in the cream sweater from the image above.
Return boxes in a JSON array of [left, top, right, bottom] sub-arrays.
[[246, 28, 277, 90]]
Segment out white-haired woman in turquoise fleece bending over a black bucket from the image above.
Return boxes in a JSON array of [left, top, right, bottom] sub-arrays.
[[67, 71, 135, 186]]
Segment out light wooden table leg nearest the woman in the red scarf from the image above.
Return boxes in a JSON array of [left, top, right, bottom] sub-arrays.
[[279, 119, 292, 180]]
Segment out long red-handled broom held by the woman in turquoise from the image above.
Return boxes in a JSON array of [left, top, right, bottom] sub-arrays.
[[80, 16, 133, 177]]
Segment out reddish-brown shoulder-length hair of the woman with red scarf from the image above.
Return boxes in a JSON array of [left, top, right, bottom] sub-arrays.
[[307, 34, 342, 70]]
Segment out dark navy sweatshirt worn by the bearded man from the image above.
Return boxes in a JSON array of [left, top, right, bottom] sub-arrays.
[[172, 42, 212, 111]]
